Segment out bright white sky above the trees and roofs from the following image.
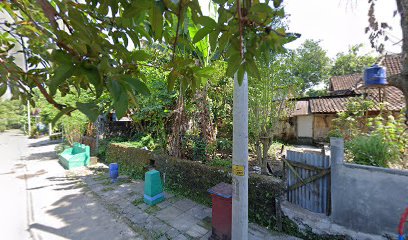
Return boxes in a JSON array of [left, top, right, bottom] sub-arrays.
[[199, 0, 402, 58]]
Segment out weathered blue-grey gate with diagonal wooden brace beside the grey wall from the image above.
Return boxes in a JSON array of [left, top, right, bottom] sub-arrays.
[[284, 150, 331, 215]]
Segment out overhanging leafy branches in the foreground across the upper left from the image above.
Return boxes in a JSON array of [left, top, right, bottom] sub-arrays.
[[0, 0, 296, 120]]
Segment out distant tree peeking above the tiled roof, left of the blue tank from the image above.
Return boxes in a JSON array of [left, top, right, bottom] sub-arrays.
[[330, 44, 377, 76]]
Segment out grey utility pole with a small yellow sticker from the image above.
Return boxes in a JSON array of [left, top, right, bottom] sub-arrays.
[[232, 73, 248, 240]]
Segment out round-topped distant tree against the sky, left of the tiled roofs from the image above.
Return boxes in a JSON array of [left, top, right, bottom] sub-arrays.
[[292, 39, 330, 91]]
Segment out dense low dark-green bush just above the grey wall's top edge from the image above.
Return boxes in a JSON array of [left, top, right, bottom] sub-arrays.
[[346, 135, 398, 167]]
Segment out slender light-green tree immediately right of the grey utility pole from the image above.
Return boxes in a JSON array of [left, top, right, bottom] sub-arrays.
[[249, 53, 303, 172]]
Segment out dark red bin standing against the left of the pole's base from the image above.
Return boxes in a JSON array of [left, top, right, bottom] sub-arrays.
[[208, 183, 232, 240]]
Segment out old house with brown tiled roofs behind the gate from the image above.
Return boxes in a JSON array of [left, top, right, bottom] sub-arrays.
[[277, 55, 405, 143]]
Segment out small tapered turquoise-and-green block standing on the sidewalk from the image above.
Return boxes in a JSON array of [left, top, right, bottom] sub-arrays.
[[143, 170, 164, 206]]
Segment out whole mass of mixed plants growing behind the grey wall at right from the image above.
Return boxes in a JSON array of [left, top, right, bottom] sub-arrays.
[[331, 98, 408, 168]]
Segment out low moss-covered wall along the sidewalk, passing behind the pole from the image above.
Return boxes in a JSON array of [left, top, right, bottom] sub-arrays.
[[106, 143, 283, 228]]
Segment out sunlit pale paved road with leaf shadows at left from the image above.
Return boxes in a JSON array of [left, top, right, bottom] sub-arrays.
[[0, 131, 141, 240]]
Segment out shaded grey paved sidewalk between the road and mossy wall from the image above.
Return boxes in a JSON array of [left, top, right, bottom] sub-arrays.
[[70, 164, 298, 240]]
